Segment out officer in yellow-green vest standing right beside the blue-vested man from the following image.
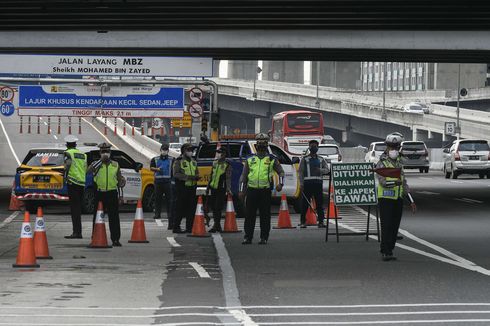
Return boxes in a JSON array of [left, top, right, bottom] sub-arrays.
[[173, 143, 199, 233]]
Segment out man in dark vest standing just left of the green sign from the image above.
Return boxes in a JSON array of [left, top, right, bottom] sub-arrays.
[[298, 140, 329, 228]]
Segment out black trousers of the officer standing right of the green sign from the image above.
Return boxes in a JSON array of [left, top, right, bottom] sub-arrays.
[[378, 198, 403, 254]]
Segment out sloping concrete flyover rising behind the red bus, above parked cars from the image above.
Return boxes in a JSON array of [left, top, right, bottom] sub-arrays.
[[214, 79, 490, 142]]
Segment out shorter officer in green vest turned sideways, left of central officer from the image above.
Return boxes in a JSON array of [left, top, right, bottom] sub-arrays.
[[206, 147, 231, 233]]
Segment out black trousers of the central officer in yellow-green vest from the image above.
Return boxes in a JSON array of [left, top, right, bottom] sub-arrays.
[[245, 188, 272, 240]]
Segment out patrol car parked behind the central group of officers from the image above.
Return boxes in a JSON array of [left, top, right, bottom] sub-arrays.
[[195, 140, 301, 215]]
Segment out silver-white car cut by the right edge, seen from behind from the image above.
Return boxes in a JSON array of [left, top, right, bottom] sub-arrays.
[[443, 139, 490, 179]]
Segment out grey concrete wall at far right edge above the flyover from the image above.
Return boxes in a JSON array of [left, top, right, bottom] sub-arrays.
[[434, 63, 487, 89]]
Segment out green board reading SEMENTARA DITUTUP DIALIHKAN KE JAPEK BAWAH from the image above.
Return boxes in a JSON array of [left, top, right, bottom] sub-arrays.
[[332, 163, 378, 206]]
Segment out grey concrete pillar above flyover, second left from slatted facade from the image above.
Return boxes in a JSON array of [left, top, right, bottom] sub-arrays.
[[262, 61, 304, 84]]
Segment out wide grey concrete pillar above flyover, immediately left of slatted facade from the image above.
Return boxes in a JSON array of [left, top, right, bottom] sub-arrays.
[[311, 61, 362, 89]]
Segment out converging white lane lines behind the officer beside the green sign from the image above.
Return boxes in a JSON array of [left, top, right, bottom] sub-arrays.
[[350, 206, 490, 276]]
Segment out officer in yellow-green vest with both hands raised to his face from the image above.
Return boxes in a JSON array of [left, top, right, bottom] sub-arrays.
[[88, 143, 126, 247]]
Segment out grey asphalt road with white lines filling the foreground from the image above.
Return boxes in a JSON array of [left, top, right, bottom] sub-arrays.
[[0, 112, 490, 325]]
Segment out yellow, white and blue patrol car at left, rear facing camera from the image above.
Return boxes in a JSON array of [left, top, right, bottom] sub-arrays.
[[14, 144, 154, 213]]
